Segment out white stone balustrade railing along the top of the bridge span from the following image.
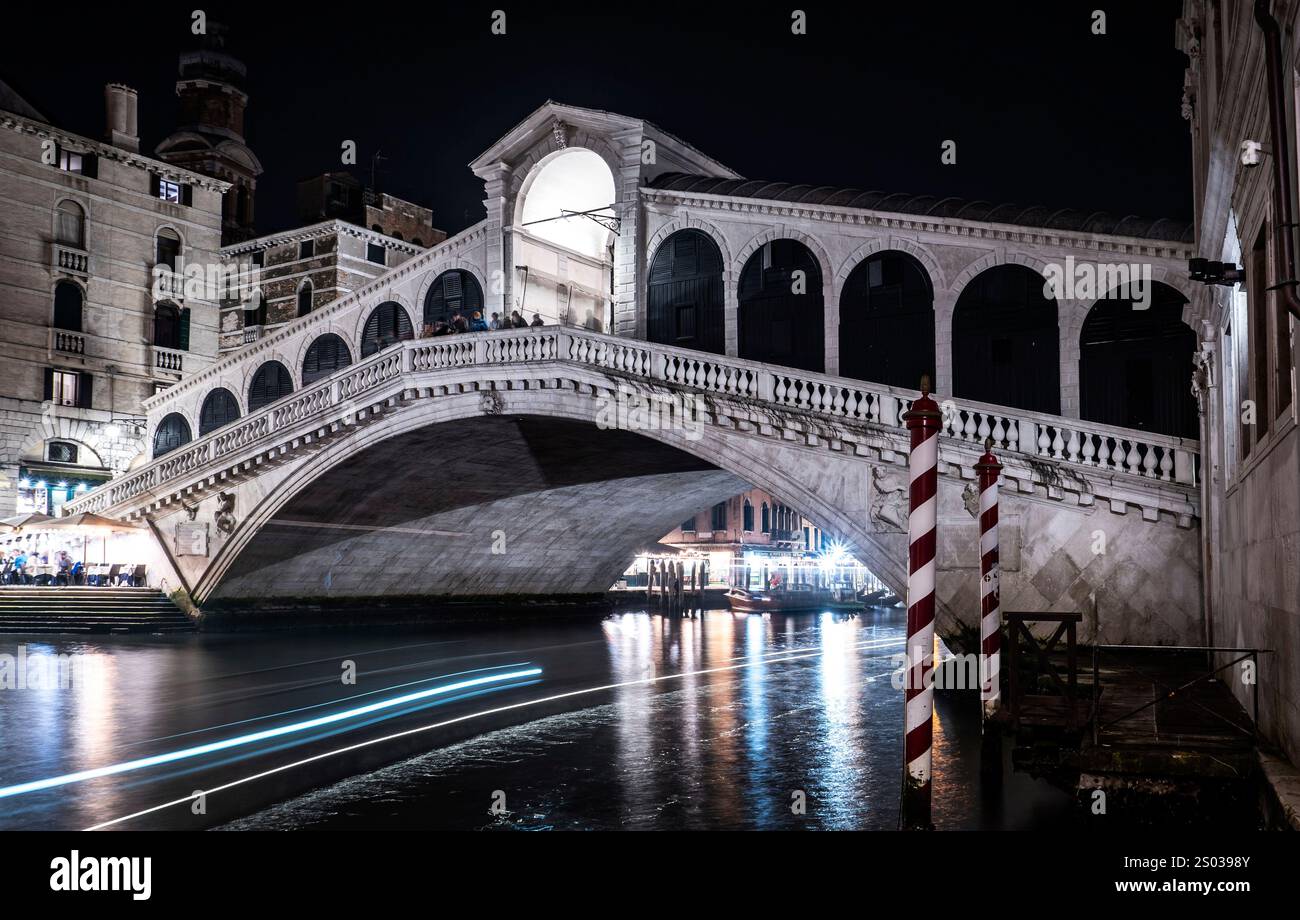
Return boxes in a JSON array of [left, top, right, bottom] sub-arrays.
[[66, 326, 1199, 512]]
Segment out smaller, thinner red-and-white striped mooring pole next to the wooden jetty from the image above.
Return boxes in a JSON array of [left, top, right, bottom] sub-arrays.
[[975, 438, 1002, 780]]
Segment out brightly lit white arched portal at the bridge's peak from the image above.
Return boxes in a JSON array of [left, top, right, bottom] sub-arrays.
[[506, 147, 618, 331]]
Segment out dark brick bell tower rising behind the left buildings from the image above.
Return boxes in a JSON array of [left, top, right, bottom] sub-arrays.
[[156, 21, 261, 246]]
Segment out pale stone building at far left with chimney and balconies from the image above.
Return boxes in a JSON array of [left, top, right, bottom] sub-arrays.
[[0, 78, 229, 515]]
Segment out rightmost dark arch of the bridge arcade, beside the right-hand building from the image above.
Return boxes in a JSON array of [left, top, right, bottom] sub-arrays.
[[1079, 282, 1200, 438]]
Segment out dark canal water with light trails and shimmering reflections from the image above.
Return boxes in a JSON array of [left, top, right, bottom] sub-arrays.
[[0, 609, 1073, 829]]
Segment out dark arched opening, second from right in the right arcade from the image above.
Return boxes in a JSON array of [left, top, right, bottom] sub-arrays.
[[953, 265, 1061, 415]]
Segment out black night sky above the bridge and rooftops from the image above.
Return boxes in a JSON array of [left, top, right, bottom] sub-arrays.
[[0, 0, 1191, 233]]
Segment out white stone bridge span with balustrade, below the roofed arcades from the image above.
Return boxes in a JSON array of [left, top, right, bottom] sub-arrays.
[[70, 326, 1201, 643]]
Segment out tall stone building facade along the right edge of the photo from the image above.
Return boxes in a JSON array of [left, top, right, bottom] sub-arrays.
[[1178, 0, 1300, 763]]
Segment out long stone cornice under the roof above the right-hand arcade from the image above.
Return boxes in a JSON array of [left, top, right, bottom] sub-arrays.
[[641, 187, 1196, 261]]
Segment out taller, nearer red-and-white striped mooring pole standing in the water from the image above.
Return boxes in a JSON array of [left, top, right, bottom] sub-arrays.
[[900, 374, 943, 830]]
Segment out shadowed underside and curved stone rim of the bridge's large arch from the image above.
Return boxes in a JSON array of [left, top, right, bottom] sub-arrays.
[[194, 390, 905, 611]]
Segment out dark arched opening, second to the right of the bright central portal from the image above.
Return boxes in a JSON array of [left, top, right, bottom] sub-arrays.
[[740, 239, 826, 372]]
